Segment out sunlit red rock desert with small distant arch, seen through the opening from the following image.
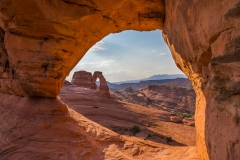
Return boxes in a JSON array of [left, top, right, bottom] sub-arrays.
[[59, 71, 197, 159]]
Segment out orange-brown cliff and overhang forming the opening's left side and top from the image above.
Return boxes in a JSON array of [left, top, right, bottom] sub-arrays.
[[0, 0, 164, 98]]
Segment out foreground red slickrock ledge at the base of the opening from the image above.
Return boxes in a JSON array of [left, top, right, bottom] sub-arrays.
[[0, 93, 197, 160]]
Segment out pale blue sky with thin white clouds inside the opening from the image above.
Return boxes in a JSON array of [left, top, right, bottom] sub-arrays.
[[67, 30, 182, 82]]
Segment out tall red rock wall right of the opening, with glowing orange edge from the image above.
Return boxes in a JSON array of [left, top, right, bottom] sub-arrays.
[[163, 0, 240, 160]]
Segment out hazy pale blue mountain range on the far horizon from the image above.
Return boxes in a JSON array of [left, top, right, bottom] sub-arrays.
[[112, 74, 187, 84]]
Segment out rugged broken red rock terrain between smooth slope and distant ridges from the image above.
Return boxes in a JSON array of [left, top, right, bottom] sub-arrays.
[[112, 84, 196, 113]]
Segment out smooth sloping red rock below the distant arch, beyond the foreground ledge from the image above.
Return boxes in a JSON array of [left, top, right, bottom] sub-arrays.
[[59, 85, 195, 146]]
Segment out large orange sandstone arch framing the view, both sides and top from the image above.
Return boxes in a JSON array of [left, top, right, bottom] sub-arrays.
[[0, 0, 240, 159]]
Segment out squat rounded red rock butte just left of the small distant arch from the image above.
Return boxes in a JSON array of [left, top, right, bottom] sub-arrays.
[[71, 71, 94, 88]]
